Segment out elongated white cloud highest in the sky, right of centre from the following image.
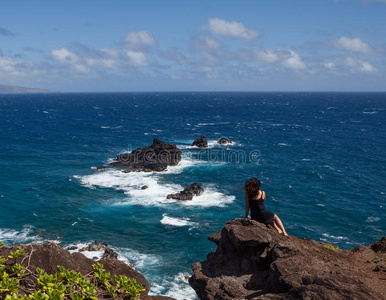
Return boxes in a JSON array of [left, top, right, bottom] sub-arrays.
[[208, 18, 259, 41]]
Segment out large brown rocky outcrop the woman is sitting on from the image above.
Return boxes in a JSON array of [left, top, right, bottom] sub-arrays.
[[189, 218, 386, 300]]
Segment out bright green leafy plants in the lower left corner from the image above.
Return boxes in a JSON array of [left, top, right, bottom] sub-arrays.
[[0, 242, 145, 300]]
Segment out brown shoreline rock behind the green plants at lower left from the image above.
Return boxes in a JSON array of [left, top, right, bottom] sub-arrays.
[[0, 243, 175, 300]]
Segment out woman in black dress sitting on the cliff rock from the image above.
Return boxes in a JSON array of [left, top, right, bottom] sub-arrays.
[[244, 178, 288, 236]]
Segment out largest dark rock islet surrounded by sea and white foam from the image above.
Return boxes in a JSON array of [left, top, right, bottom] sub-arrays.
[[109, 138, 181, 172]]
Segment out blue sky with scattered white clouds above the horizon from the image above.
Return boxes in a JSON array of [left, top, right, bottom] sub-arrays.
[[0, 0, 386, 92]]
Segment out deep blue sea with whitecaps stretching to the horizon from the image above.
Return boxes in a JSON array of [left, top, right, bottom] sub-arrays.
[[0, 92, 386, 299]]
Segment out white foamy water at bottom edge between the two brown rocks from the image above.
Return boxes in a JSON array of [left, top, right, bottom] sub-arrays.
[[149, 273, 198, 300]]
